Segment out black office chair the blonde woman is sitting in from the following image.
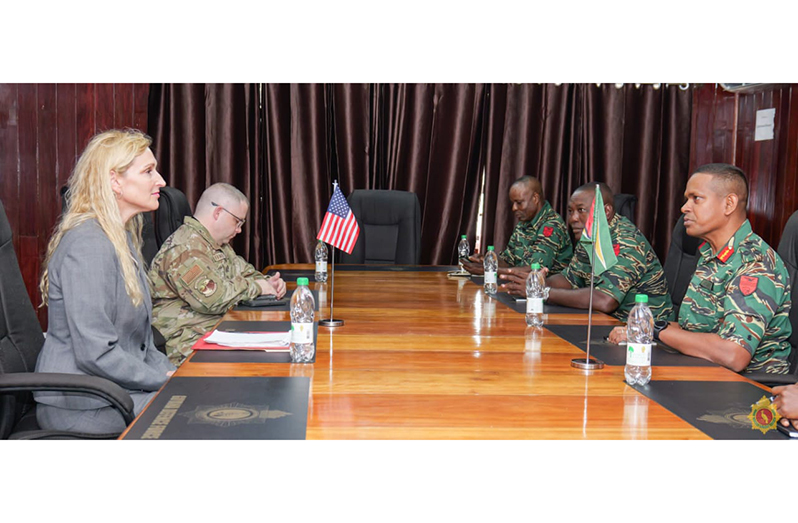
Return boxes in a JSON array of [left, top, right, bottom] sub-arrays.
[[0, 202, 134, 439]]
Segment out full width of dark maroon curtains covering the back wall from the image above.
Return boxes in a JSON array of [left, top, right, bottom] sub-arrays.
[[149, 84, 691, 266]]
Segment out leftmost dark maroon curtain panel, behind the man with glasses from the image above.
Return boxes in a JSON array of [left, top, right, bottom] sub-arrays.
[[148, 84, 268, 267]]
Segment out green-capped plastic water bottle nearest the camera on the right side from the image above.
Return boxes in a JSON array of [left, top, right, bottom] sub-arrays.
[[623, 294, 654, 385]]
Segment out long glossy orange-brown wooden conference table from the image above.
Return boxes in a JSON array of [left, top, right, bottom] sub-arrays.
[[125, 264, 768, 439]]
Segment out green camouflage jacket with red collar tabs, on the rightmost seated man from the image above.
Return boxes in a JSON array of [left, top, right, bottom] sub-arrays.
[[679, 220, 792, 374]]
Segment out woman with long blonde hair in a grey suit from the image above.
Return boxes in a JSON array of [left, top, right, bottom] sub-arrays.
[[34, 130, 175, 434]]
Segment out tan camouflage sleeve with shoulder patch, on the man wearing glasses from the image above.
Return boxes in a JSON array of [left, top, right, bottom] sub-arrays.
[[166, 246, 260, 314]]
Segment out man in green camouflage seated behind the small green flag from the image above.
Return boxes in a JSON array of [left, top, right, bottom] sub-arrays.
[[499, 183, 673, 321]]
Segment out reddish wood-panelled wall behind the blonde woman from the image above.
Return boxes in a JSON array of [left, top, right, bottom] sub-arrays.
[[0, 84, 149, 328]]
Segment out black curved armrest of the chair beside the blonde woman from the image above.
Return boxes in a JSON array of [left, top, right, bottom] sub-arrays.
[[0, 372, 136, 425]]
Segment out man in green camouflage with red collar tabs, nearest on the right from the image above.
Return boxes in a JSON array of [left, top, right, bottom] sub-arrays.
[[612, 164, 792, 374]]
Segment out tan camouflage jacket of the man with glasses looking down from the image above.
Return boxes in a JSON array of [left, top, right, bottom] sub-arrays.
[[147, 216, 267, 365]]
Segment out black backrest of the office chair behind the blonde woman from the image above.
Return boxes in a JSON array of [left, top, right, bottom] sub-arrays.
[[0, 198, 44, 438]]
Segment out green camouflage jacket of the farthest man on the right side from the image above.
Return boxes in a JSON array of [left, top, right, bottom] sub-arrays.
[[500, 202, 573, 274]]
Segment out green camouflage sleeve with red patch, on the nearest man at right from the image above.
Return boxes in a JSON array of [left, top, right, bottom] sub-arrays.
[[718, 262, 789, 355]]
